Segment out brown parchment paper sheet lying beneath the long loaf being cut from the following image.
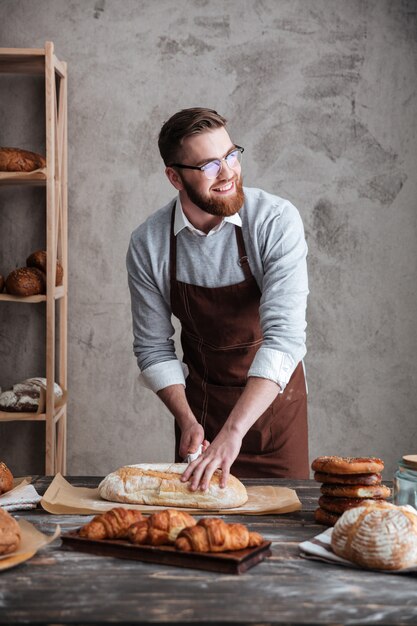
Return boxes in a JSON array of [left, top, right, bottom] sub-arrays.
[[41, 474, 301, 515]]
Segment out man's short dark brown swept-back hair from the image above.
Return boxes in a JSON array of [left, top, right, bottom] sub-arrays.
[[158, 107, 227, 165]]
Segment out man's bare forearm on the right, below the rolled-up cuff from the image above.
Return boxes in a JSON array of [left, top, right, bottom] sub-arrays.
[[222, 376, 280, 439]]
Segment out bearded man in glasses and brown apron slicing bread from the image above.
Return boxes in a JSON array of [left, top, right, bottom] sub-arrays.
[[127, 108, 309, 490]]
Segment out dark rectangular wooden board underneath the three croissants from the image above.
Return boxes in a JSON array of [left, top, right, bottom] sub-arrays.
[[61, 531, 271, 574]]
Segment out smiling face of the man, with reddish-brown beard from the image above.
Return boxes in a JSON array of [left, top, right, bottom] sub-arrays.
[[173, 128, 244, 217]]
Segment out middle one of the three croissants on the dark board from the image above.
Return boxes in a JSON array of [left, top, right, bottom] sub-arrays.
[[128, 509, 197, 546]]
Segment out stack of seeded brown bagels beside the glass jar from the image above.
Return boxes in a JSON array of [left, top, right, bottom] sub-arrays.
[[311, 456, 391, 526]]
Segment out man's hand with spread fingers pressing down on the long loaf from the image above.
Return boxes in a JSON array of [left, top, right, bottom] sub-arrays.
[[181, 429, 242, 491]]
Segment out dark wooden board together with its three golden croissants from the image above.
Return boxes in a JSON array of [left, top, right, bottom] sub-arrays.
[[62, 507, 271, 574]]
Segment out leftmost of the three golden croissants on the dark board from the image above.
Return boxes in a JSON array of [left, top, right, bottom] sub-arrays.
[[79, 507, 143, 539]]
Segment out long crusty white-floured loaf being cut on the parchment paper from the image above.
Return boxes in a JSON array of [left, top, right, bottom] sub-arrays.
[[99, 463, 248, 509]]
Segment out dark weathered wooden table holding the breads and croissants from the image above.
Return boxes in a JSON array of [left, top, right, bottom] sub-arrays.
[[0, 477, 417, 626]]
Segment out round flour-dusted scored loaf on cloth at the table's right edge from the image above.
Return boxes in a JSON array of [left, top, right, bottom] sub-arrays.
[[331, 501, 417, 570]]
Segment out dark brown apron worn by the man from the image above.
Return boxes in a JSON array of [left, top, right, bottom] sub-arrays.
[[170, 205, 309, 478]]
